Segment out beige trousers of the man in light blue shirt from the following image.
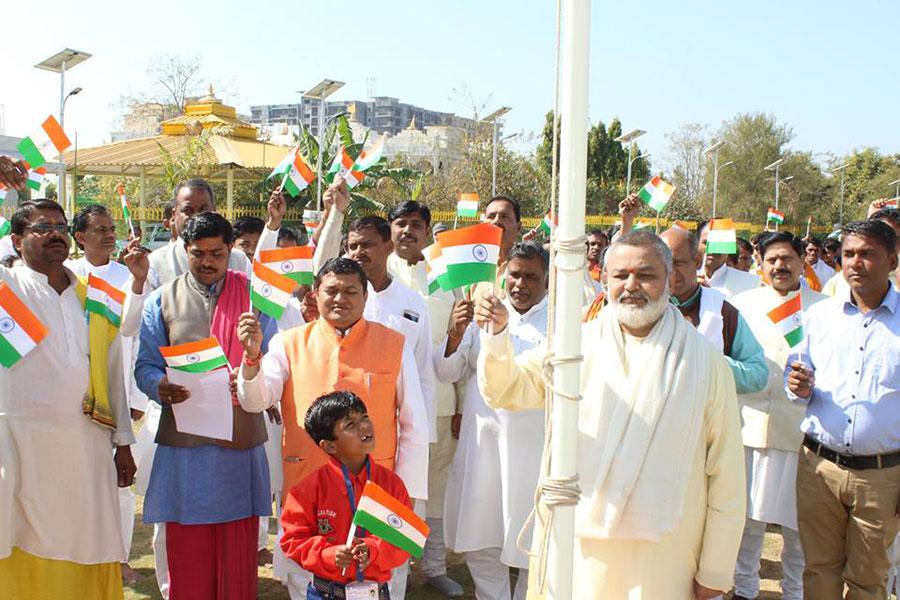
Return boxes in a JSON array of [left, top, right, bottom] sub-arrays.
[[797, 447, 900, 600]]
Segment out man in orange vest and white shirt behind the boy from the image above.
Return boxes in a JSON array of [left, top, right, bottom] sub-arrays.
[[238, 258, 428, 598]]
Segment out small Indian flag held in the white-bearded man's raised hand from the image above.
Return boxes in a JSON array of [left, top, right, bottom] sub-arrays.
[[437, 223, 503, 289]]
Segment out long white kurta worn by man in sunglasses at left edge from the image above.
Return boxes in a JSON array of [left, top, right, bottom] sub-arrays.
[[0, 266, 134, 564]]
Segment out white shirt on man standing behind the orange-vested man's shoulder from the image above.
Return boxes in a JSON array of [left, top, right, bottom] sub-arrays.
[[363, 279, 437, 442]]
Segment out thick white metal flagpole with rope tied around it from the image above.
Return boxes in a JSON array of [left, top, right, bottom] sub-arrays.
[[547, 0, 591, 600]]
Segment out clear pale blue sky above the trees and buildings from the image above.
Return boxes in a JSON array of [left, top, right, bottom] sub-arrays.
[[0, 0, 900, 171]]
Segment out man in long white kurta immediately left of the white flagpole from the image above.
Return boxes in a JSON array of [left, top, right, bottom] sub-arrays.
[[436, 242, 548, 600]]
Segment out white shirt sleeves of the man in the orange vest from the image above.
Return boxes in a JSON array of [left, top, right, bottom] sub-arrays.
[[237, 333, 428, 500]]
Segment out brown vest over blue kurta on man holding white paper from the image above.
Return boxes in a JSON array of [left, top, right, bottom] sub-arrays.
[[156, 273, 268, 450]]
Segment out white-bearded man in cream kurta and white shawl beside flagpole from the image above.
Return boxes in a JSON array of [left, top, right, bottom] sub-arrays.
[[475, 231, 745, 600]]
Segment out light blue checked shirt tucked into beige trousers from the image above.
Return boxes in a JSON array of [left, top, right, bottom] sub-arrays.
[[785, 286, 900, 455]]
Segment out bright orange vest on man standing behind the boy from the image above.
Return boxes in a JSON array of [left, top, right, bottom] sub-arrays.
[[281, 319, 403, 494]]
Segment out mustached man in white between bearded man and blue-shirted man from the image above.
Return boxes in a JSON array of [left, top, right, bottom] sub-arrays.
[[731, 232, 826, 600]]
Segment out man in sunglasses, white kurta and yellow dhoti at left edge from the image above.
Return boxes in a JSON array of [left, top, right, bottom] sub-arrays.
[[0, 200, 134, 600]]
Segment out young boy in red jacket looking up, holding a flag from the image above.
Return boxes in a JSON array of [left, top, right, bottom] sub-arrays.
[[281, 392, 411, 600]]
